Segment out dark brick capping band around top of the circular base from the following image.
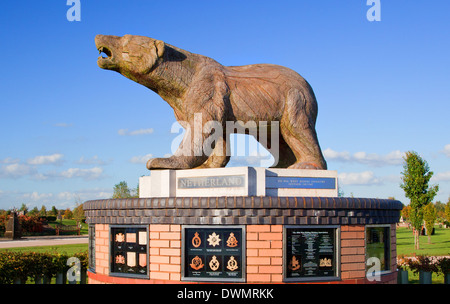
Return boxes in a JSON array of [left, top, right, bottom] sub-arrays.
[[83, 196, 403, 225]]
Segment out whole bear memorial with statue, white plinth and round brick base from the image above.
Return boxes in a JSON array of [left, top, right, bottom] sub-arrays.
[[84, 35, 402, 284]]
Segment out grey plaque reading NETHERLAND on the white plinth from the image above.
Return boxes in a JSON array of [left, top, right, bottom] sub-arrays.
[[177, 175, 245, 189]]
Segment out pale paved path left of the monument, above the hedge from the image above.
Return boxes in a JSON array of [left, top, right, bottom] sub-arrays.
[[0, 236, 88, 248]]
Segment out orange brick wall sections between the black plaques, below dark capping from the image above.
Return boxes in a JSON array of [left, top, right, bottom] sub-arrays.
[[89, 224, 396, 283]]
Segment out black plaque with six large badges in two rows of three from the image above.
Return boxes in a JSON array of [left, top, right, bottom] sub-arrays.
[[183, 226, 245, 282]]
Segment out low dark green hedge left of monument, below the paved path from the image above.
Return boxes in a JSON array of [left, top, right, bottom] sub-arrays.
[[0, 250, 88, 284]]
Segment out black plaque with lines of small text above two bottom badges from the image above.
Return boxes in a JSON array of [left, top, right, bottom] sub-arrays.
[[284, 226, 338, 281]]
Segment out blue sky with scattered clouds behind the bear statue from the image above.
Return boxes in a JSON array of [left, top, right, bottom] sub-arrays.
[[0, 0, 450, 209]]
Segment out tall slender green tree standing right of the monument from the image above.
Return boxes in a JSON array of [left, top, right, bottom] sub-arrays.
[[400, 151, 439, 249]]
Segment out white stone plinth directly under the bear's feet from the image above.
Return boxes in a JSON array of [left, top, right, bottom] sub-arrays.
[[139, 167, 338, 198]]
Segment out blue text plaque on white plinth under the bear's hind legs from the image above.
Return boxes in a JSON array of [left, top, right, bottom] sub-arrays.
[[266, 176, 336, 189]]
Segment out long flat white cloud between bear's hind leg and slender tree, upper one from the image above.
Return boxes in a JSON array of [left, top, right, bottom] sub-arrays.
[[323, 148, 404, 167]]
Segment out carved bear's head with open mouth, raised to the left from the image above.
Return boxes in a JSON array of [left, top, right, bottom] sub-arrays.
[[95, 35, 165, 79]]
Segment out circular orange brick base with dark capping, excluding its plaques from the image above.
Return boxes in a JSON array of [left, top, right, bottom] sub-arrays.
[[84, 197, 402, 284]]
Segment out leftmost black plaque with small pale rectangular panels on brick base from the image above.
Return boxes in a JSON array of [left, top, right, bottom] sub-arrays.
[[110, 225, 148, 277]]
